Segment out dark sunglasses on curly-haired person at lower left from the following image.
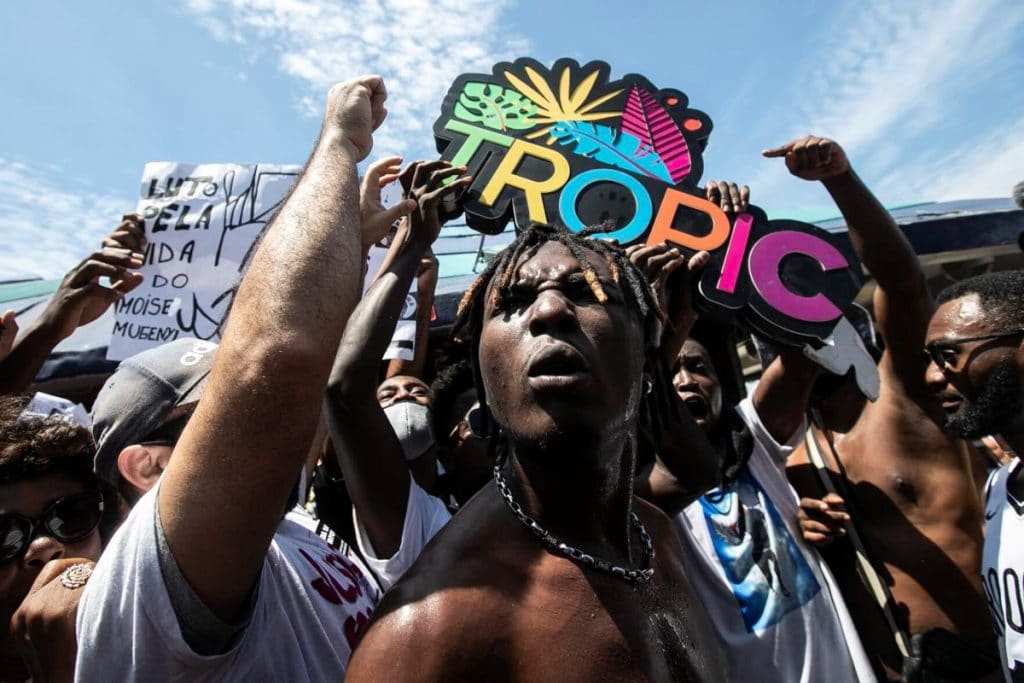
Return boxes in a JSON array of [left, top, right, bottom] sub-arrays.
[[0, 490, 103, 564]]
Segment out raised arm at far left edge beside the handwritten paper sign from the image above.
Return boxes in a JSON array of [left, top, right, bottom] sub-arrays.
[[0, 213, 145, 394]]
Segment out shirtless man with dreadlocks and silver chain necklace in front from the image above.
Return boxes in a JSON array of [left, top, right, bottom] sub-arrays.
[[348, 225, 723, 681]]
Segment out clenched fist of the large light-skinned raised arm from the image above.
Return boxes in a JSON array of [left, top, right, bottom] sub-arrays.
[[324, 76, 387, 161]]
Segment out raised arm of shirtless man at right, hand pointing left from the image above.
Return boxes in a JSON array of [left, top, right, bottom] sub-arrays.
[[763, 135, 933, 395]]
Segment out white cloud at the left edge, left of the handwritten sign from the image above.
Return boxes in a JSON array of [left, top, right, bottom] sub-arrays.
[[0, 158, 134, 281]]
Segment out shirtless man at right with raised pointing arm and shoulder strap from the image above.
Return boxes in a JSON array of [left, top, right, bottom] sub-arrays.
[[764, 136, 994, 680]]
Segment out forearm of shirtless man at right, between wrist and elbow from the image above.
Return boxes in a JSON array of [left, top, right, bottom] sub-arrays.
[[823, 169, 924, 290]]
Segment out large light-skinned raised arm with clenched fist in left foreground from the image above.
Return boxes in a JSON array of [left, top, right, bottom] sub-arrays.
[[158, 76, 409, 621]]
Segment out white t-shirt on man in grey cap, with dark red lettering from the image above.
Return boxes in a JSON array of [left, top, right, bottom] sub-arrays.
[[75, 488, 381, 682]]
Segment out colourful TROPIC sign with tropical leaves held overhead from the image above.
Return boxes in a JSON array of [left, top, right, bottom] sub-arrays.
[[434, 58, 862, 345]]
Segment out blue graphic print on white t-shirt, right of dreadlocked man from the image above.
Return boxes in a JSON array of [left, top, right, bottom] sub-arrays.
[[700, 469, 821, 633]]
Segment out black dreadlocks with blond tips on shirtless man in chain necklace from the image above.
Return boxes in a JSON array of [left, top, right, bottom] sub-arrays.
[[453, 223, 671, 445]]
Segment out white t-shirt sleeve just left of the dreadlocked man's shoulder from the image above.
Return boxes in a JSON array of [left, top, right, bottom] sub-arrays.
[[352, 477, 452, 591]]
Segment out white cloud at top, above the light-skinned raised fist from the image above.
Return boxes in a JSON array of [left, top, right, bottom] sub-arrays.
[[186, 0, 527, 157]]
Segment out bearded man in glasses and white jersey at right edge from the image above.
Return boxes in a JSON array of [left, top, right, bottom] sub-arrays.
[[925, 270, 1024, 683]]
